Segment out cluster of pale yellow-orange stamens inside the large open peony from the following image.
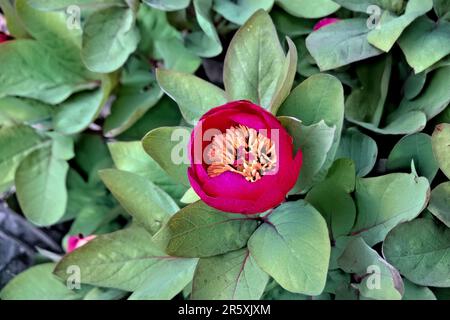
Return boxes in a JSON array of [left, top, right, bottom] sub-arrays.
[[205, 125, 277, 182]]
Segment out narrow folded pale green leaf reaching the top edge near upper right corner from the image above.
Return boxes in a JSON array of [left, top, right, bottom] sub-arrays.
[[367, 0, 433, 52]]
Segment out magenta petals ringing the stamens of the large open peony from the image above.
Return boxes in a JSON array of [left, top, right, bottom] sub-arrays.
[[188, 100, 302, 214]]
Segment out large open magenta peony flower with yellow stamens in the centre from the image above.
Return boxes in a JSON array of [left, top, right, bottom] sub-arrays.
[[188, 101, 302, 214]]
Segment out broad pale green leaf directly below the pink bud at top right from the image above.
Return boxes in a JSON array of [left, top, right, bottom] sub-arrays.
[[306, 18, 382, 71]]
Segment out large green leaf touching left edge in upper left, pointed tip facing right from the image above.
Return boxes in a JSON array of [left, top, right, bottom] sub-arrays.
[[0, 40, 96, 104]]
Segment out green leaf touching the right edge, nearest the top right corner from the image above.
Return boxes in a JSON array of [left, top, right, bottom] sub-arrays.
[[398, 16, 450, 73]]
